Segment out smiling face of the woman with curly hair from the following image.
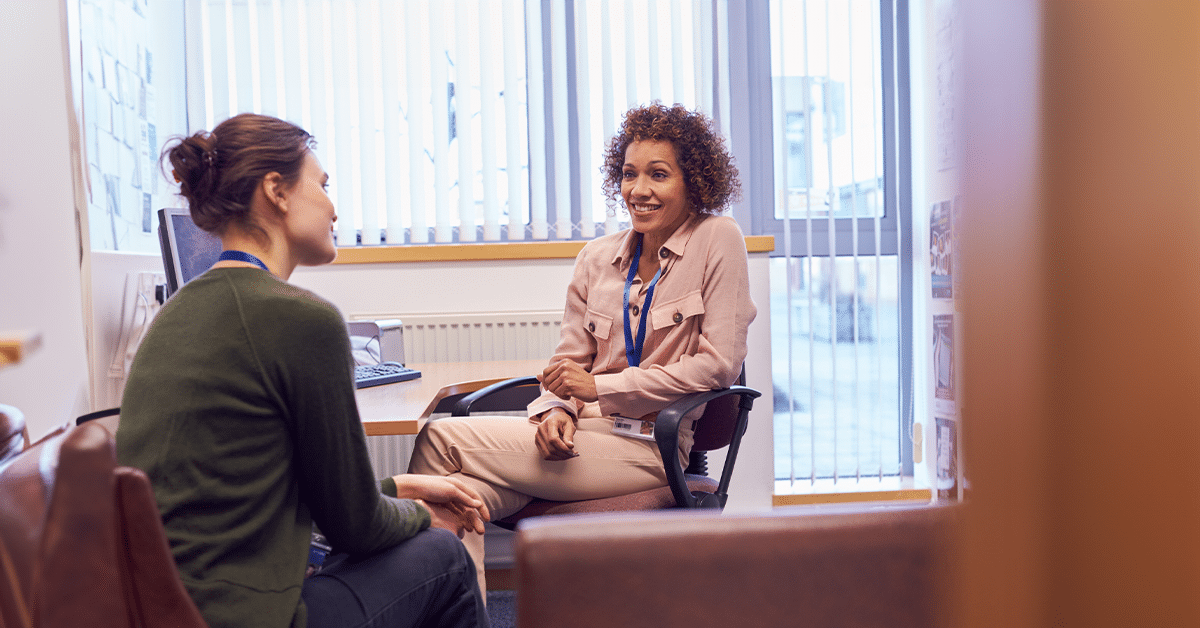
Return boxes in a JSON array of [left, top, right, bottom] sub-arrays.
[[620, 139, 691, 247]]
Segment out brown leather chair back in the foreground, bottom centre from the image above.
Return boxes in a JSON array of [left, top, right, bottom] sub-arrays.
[[516, 504, 959, 628]]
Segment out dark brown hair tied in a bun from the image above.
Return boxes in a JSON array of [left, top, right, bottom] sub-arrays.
[[161, 113, 316, 235]]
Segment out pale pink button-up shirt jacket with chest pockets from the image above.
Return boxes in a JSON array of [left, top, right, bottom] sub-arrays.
[[528, 214, 757, 427]]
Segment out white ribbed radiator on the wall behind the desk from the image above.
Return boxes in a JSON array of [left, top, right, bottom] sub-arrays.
[[350, 310, 563, 478]]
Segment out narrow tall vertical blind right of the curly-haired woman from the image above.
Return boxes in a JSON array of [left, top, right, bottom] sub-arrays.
[[770, 0, 901, 485]]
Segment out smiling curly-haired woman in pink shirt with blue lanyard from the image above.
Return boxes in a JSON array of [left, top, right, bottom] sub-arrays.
[[409, 102, 756, 586]]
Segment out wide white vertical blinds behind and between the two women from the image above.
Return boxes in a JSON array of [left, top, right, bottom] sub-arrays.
[[188, 0, 728, 246]]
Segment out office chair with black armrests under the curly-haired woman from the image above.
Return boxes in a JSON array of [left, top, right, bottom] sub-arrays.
[[450, 366, 761, 530]]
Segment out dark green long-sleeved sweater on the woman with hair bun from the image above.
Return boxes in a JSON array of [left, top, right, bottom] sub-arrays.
[[116, 268, 430, 628]]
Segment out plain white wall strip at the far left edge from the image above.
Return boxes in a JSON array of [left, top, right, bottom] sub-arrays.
[[0, 0, 88, 438]]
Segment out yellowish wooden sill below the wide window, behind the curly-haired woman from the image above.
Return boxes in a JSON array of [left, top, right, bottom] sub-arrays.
[[334, 235, 775, 264]]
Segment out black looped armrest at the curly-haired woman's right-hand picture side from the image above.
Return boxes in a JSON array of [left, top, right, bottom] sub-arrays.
[[654, 385, 761, 508]]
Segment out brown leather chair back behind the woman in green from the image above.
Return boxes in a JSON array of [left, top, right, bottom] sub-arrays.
[[0, 421, 204, 628]]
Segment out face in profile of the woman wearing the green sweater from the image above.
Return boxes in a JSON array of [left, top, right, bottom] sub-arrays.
[[284, 151, 337, 265]]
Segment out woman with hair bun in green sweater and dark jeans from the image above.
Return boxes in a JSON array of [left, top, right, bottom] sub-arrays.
[[116, 114, 488, 628]]
